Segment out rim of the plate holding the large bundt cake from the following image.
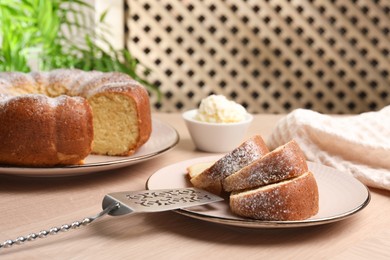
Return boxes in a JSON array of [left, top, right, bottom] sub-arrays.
[[0, 117, 180, 177]]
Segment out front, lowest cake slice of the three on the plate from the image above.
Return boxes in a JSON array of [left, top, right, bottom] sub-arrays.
[[230, 172, 319, 221]]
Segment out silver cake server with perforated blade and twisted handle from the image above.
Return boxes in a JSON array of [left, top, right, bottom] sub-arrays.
[[0, 188, 223, 249]]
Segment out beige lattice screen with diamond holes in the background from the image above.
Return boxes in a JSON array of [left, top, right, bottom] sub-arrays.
[[126, 0, 390, 113]]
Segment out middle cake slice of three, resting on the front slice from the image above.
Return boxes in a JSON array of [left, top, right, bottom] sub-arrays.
[[223, 140, 308, 192]]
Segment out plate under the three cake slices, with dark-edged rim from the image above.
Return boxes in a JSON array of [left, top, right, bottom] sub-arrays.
[[146, 156, 370, 228]]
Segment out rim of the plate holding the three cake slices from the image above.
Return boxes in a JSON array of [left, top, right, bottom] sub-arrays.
[[145, 156, 371, 229]]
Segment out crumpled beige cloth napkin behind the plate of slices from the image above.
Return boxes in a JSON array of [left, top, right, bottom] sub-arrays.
[[267, 106, 390, 190]]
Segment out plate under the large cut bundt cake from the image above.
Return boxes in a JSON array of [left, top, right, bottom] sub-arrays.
[[0, 119, 179, 177]]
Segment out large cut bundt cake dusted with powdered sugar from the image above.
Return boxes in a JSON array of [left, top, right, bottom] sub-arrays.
[[0, 69, 152, 166]]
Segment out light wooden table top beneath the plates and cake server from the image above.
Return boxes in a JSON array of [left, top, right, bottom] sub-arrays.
[[0, 114, 390, 259]]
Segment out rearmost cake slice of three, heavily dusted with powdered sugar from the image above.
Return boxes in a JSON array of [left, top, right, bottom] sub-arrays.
[[190, 135, 269, 194]]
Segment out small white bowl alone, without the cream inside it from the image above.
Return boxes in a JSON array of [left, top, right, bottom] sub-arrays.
[[183, 109, 253, 153]]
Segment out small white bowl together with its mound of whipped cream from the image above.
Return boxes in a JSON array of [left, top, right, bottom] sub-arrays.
[[183, 95, 253, 153]]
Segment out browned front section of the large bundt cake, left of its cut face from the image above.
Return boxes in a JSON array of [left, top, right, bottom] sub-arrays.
[[0, 94, 93, 167]]
